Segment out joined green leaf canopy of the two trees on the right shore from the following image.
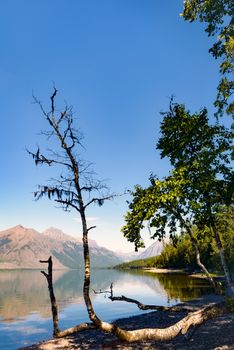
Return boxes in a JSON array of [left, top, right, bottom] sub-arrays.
[[122, 101, 233, 253]]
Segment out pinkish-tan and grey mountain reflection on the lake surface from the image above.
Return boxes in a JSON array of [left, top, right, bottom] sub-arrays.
[[0, 270, 120, 322]]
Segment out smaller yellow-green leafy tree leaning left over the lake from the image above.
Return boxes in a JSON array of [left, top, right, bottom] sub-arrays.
[[122, 168, 215, 287]]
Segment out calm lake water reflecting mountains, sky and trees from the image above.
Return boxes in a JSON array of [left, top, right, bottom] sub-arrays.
[[0, 270, 210, 350]]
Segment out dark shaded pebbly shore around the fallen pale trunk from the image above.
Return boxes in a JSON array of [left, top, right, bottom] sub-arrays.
[[19, 294, 234, 350]]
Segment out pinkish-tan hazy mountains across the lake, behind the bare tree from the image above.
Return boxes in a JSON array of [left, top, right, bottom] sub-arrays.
[[0, 225, 122, 269]]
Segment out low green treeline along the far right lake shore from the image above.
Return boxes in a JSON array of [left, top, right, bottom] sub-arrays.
[[117, 207, 234, 272]]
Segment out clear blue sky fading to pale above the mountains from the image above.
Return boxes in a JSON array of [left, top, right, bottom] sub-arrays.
[[0, 0, 219, 251]]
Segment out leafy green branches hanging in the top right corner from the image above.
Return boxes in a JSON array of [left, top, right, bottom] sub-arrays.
[[181, 0, 234, 115]]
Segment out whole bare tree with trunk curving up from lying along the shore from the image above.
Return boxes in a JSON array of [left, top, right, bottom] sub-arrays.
[[28, 88, 227, 342]]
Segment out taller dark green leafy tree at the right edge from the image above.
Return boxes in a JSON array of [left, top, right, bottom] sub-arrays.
[[157, 102, 234, 293]]
